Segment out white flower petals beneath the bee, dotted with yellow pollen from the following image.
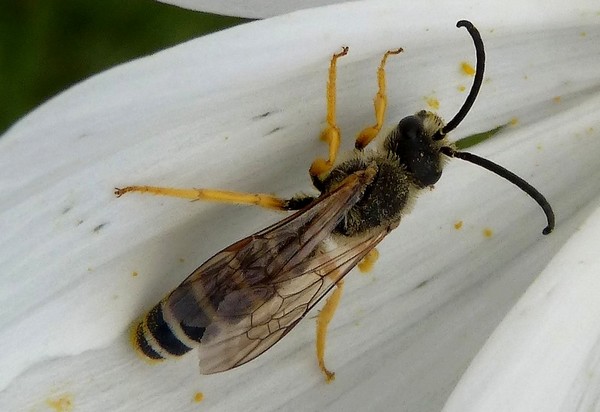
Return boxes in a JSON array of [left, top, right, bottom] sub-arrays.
[[0, 0, 600, 411]]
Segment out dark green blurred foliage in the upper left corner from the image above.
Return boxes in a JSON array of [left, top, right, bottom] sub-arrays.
[[0, 0, 246, 133]]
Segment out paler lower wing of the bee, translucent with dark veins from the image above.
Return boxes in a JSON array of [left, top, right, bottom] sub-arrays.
[[200, 229, 388, 374]]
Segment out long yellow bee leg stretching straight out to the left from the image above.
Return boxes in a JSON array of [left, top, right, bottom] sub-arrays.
[[115, 186, 314, 210]]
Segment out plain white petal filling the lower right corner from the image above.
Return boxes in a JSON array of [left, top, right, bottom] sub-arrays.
[[444, 199, 600, 411]]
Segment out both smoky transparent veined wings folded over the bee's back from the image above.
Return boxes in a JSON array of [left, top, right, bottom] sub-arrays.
[[163, 172, 388, 374]]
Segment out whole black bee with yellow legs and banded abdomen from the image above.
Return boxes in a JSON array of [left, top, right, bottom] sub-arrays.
[[115, 20, 554, 381]]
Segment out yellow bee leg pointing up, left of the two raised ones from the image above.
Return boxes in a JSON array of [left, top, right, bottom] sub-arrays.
[[308, 47, 348, 176]]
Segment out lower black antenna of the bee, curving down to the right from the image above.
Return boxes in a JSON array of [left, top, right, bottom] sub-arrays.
[[440, 146, 554, 235]]
